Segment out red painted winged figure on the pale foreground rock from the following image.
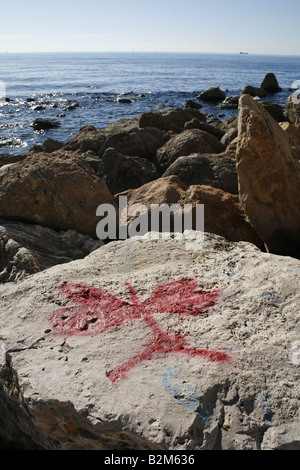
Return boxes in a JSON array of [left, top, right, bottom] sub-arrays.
[[51, 279, 230, 383]]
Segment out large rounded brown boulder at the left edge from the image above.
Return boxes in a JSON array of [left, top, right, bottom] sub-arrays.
[[0, 151, 114, 237]]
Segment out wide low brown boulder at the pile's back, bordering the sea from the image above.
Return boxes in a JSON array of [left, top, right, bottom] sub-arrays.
[[139, 107, 206, 133]]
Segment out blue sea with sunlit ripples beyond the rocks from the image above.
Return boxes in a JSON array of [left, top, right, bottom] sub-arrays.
[[0, 52, 300, 154]]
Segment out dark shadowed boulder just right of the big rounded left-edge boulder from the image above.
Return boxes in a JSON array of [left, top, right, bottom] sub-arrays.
[[97, 148, 159, 194]]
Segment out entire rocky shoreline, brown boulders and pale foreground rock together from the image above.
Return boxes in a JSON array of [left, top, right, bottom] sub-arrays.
[[0, 74, 300, 450]]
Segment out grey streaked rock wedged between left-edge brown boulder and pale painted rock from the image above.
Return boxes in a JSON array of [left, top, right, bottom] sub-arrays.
[[0, 222, 103, 282]]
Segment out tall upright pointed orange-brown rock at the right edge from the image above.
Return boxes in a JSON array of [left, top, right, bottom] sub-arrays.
[[237, 95, 300, 257]]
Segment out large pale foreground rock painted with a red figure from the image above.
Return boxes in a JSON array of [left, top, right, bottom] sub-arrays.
[[0, 234, 300, 450]]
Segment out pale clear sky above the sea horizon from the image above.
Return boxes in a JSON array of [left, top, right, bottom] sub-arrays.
[[0, 0, 300, 55]]
